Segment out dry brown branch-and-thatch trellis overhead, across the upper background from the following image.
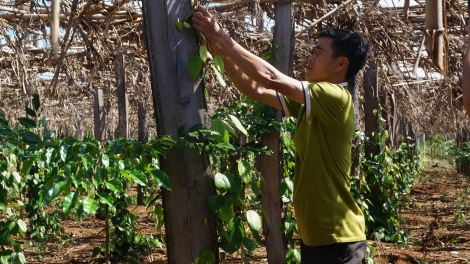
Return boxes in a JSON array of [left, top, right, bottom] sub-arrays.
[[0, 0, 468, 136]]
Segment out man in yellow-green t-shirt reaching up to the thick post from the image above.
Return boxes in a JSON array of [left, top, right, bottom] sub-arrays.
[[192, 7, 369, 264]]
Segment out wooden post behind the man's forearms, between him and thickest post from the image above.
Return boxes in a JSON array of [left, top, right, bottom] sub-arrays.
[[260, 3, 295, 263]]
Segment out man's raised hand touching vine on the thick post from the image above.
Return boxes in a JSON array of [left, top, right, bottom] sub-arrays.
[[193, 6, 224, 42]]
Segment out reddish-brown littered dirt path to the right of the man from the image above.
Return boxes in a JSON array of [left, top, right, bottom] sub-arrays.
[[371, 161, 470, 264]]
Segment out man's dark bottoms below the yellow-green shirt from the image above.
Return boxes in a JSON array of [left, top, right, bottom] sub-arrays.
[[300, 240, 367, 264]]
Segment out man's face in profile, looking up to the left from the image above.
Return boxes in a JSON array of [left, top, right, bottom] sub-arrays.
[[305, 37, 345, 82]]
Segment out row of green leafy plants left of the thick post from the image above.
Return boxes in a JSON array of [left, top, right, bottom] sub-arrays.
[[0, 95, 176, 263]]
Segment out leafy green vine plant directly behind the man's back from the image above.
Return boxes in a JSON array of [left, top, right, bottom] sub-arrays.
[[359, 118, 423, 245]]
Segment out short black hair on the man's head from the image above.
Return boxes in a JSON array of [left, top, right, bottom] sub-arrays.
[[318, 28, 370, 80]]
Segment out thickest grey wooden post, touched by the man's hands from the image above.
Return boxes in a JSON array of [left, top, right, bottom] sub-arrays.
[[142, 0, 217, 263]]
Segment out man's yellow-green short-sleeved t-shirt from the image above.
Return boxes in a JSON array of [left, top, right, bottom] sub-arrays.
[[280, 82, 366, 246]]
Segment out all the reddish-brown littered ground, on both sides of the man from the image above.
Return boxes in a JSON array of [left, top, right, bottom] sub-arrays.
[[25, 161, 470, 264]]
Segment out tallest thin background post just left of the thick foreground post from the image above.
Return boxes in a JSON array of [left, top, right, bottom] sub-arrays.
[[116, 53, 129, 138]]
